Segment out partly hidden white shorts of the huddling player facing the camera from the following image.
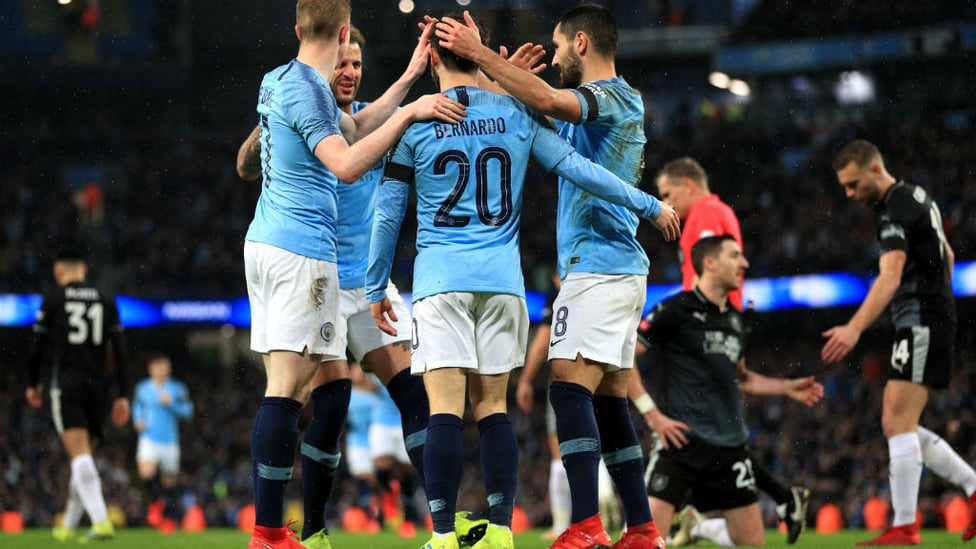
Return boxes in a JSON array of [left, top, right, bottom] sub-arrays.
[[336, 282, 411, 363]]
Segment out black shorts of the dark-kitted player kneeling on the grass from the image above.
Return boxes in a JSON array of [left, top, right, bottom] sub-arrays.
[[647, 438, 759, 512]]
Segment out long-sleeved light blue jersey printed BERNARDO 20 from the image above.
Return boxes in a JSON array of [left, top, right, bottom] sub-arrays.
[[366, 87, 660, 303]]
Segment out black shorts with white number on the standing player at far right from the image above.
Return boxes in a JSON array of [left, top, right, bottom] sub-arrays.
[[888, 325, 956, 389]]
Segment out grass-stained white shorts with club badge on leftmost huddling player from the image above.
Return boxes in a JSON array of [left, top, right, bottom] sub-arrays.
[[244, 241, 346, 360]]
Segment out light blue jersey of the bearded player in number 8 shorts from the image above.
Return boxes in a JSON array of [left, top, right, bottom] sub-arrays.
[[556, 76, 650, 278]]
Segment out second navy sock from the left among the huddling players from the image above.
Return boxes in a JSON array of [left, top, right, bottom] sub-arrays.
[[302, 379, 352, 539]]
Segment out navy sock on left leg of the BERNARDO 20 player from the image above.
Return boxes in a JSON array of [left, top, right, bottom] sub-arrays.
[[424, 414, 464, 534]]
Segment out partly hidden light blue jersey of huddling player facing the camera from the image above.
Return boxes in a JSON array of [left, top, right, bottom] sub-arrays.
[[336, 101, 386, 290]]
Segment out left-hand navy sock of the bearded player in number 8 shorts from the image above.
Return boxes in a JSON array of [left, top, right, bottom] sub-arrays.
[[549, 381, 600, 522]]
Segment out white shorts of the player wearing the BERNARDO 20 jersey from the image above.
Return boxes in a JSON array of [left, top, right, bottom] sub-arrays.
[[410, 292, 529, 375]]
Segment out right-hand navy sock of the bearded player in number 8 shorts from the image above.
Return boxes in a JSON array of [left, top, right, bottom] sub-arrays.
[[593, 396, 651, 527]]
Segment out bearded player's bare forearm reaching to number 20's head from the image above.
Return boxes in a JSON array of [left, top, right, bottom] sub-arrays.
[[433, 11, 583, 123]]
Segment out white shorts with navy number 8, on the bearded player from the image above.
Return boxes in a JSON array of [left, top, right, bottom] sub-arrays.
[[549, 273, 647, 372]]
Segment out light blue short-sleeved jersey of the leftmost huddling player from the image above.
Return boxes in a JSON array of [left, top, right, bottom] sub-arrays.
[[245, 60, 339, 262]]
